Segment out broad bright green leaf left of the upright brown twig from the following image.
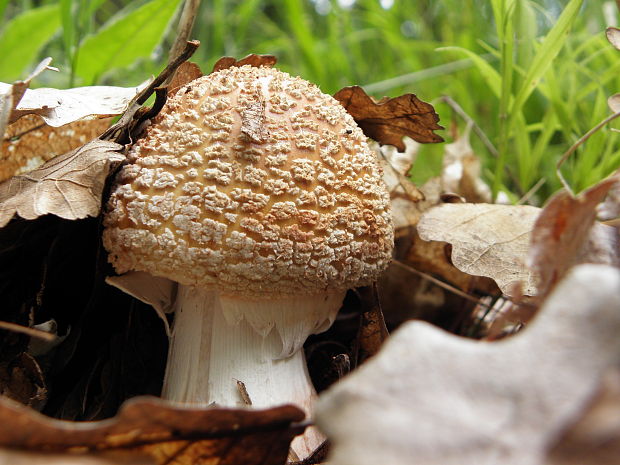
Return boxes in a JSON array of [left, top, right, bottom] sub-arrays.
[[75, 0, 180, 84]]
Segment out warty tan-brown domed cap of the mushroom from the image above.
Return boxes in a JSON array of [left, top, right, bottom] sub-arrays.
[[103, 66, 393, 298]]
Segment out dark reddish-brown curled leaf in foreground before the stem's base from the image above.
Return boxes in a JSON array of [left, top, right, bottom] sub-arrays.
[[0, 397, 304, 465]]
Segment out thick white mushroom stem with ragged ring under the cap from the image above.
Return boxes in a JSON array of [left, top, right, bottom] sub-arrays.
[[162, 285, 344, 459]]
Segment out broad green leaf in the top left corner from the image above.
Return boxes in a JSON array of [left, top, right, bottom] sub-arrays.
[[0, 5, 60, 82]]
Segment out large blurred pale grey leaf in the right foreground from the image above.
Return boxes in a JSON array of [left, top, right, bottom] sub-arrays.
[[317, 265, 620, 465]]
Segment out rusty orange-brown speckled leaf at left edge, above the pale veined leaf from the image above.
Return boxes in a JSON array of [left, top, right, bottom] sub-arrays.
[[0, 115, 110, 182]]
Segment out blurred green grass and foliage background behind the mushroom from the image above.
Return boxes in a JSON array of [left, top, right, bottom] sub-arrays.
[[0, 0, 620, 204]]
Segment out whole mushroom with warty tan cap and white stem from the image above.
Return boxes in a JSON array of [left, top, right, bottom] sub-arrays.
[[103, 66, 393, 458]]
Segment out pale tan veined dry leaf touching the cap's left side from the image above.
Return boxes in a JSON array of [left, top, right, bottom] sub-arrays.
[[0, 140, 125, 227]]
